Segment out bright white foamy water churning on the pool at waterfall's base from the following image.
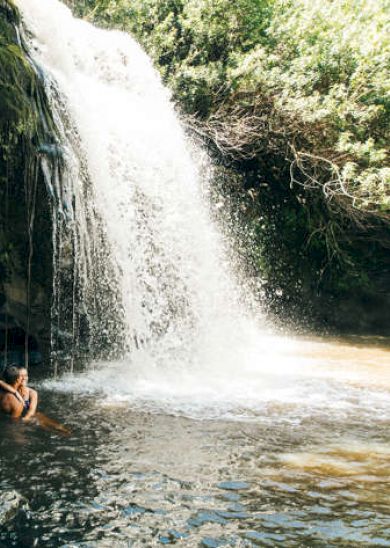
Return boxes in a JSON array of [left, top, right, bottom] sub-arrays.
[[40, 336, 390, 427]]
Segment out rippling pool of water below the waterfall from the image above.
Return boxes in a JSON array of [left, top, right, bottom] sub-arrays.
[[0, 339, 390, 547]]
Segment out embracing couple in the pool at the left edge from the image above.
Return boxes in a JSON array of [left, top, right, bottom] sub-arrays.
[[0, 365, 38, 421]]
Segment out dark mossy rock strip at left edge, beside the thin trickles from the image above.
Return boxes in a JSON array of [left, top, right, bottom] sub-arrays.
[[0, 0, 53, 365]]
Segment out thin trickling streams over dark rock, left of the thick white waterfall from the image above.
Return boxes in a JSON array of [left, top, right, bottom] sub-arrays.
[[16, 11, 123, 371]]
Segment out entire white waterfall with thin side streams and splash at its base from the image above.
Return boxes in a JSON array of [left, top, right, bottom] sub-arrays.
[[17, 0, 308, 416]]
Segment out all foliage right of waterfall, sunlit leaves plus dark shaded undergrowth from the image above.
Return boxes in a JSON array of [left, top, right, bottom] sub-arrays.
[[69, 0, 390, 330]]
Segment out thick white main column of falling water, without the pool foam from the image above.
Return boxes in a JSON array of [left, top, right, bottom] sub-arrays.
[[16, 1, 272, 363]]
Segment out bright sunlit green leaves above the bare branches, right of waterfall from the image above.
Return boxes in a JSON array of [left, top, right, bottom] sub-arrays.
[[74, 0, 390, 213]]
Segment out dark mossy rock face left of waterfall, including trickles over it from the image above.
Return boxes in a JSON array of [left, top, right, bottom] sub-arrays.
[[0, 0, 123, 368]]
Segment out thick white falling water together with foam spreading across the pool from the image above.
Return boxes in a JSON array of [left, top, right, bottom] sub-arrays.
[[17, 0, 388, 417]]
